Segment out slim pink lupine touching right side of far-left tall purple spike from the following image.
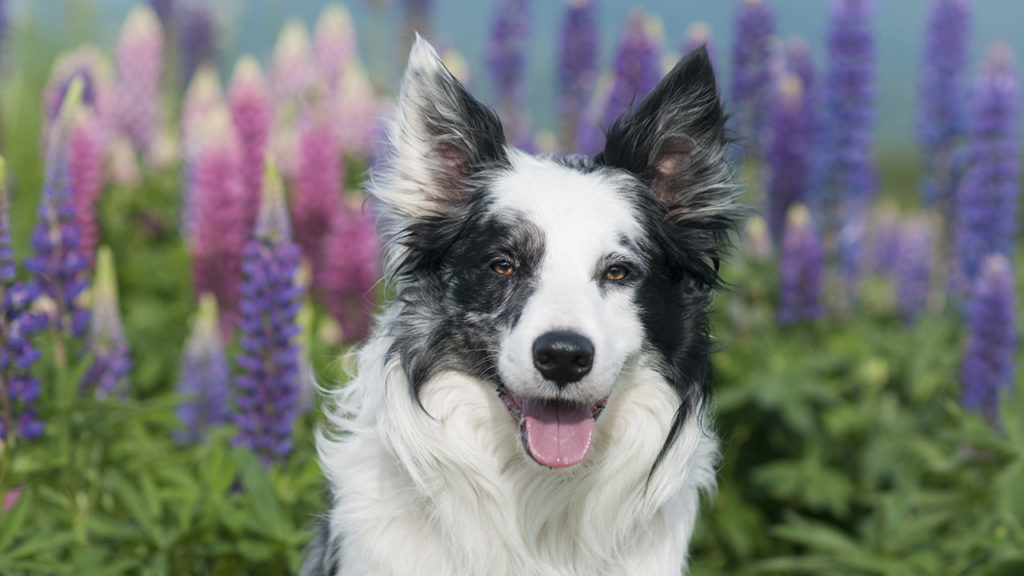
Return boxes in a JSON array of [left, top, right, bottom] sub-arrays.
[[71, 109, 106, 266]]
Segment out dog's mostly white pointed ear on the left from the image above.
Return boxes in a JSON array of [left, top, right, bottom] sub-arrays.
[[375, 35, 508, 218]]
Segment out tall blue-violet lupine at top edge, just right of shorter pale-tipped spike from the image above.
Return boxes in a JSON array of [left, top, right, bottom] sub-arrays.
[[821, 0, 876, 292]]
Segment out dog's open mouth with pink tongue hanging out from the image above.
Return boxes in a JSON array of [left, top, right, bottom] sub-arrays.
[[519, 399, 594, 468]]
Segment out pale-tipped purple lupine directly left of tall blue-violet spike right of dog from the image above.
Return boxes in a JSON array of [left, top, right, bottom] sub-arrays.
[[767, 74, 814, 244]]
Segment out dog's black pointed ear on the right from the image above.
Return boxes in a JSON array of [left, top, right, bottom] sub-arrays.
[[594, 47, 737, 230]]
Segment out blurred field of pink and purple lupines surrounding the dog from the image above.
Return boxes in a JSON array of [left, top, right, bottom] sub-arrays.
[[0, 0, 1024, 576]]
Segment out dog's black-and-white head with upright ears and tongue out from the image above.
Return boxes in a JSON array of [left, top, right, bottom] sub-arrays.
[[372, 39, 737, 467]]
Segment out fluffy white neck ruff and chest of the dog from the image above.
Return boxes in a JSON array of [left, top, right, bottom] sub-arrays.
[[317, 327, 717, 575]]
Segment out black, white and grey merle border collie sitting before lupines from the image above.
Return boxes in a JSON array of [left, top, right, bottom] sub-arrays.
[[303, 39, 740, 576]]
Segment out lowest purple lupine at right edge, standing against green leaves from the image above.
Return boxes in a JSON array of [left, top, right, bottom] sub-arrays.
[[961, 254, 1018, 423]]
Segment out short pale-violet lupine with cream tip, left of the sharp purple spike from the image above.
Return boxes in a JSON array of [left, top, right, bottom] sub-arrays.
[[175, 293, 231, 444]]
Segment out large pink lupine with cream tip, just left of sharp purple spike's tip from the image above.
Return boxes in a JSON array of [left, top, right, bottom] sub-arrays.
[[193, 107, 247, 337]]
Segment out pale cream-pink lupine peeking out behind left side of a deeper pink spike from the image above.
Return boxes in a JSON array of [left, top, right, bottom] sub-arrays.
[[181, 66, 226, 243]]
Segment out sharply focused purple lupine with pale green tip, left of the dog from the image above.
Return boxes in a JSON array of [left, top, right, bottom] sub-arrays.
[[234, 161, 303, 464]]
